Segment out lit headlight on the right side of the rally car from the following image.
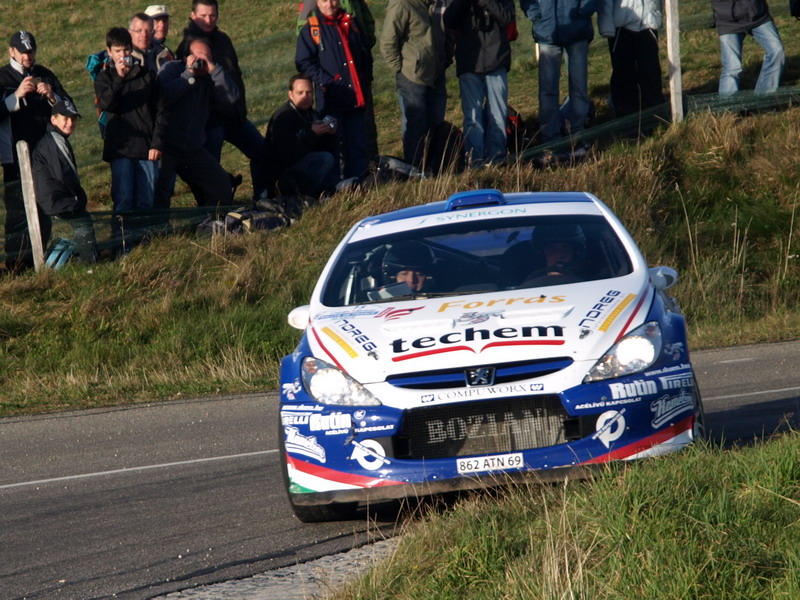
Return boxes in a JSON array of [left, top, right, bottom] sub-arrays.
[[583, 321, 661, 383]]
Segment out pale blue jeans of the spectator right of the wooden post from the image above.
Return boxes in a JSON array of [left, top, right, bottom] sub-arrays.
[[719, 21, 786, 96]]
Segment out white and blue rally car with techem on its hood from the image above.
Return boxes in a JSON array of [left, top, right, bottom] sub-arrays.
[[279, 190, 705, 522]]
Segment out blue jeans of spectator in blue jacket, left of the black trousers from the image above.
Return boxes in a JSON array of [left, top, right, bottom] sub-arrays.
[[539, 40, 589, 142]]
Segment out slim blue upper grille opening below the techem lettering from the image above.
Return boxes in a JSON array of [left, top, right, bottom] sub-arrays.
[[386, 357, 572, 390]]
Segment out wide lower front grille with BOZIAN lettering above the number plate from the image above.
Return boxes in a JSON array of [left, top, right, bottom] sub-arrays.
[[395, 395, 568, 459]]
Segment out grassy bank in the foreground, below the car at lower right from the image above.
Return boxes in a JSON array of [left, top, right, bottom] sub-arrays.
[[335, 432, 800, 600]]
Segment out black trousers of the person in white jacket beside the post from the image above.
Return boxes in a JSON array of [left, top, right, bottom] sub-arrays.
[[608, 28, 664, 117]]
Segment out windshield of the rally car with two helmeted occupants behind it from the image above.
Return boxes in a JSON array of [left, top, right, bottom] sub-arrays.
[[322, 215, 632, 306]]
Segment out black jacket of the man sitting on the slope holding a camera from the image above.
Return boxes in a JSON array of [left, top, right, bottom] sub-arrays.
[[264, 100, 336, 184]]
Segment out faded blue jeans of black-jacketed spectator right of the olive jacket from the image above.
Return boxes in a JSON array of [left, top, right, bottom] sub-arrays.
[[458, 69, 508, 165]]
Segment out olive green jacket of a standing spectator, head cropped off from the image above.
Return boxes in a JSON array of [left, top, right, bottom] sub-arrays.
[[380, 0, 446, 87]]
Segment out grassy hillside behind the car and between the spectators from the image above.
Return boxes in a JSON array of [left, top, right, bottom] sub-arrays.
[[0, 0, 800, 415]]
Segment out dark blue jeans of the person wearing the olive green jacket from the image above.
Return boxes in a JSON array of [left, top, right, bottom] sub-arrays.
[[395, 73, 447, 168]]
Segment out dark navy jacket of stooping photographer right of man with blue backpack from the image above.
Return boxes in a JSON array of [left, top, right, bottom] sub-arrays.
[[157, 60, 239, 153]]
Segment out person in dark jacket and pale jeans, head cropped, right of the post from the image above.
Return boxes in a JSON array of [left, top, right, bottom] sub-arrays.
[[711, 0, 786, 96]]
